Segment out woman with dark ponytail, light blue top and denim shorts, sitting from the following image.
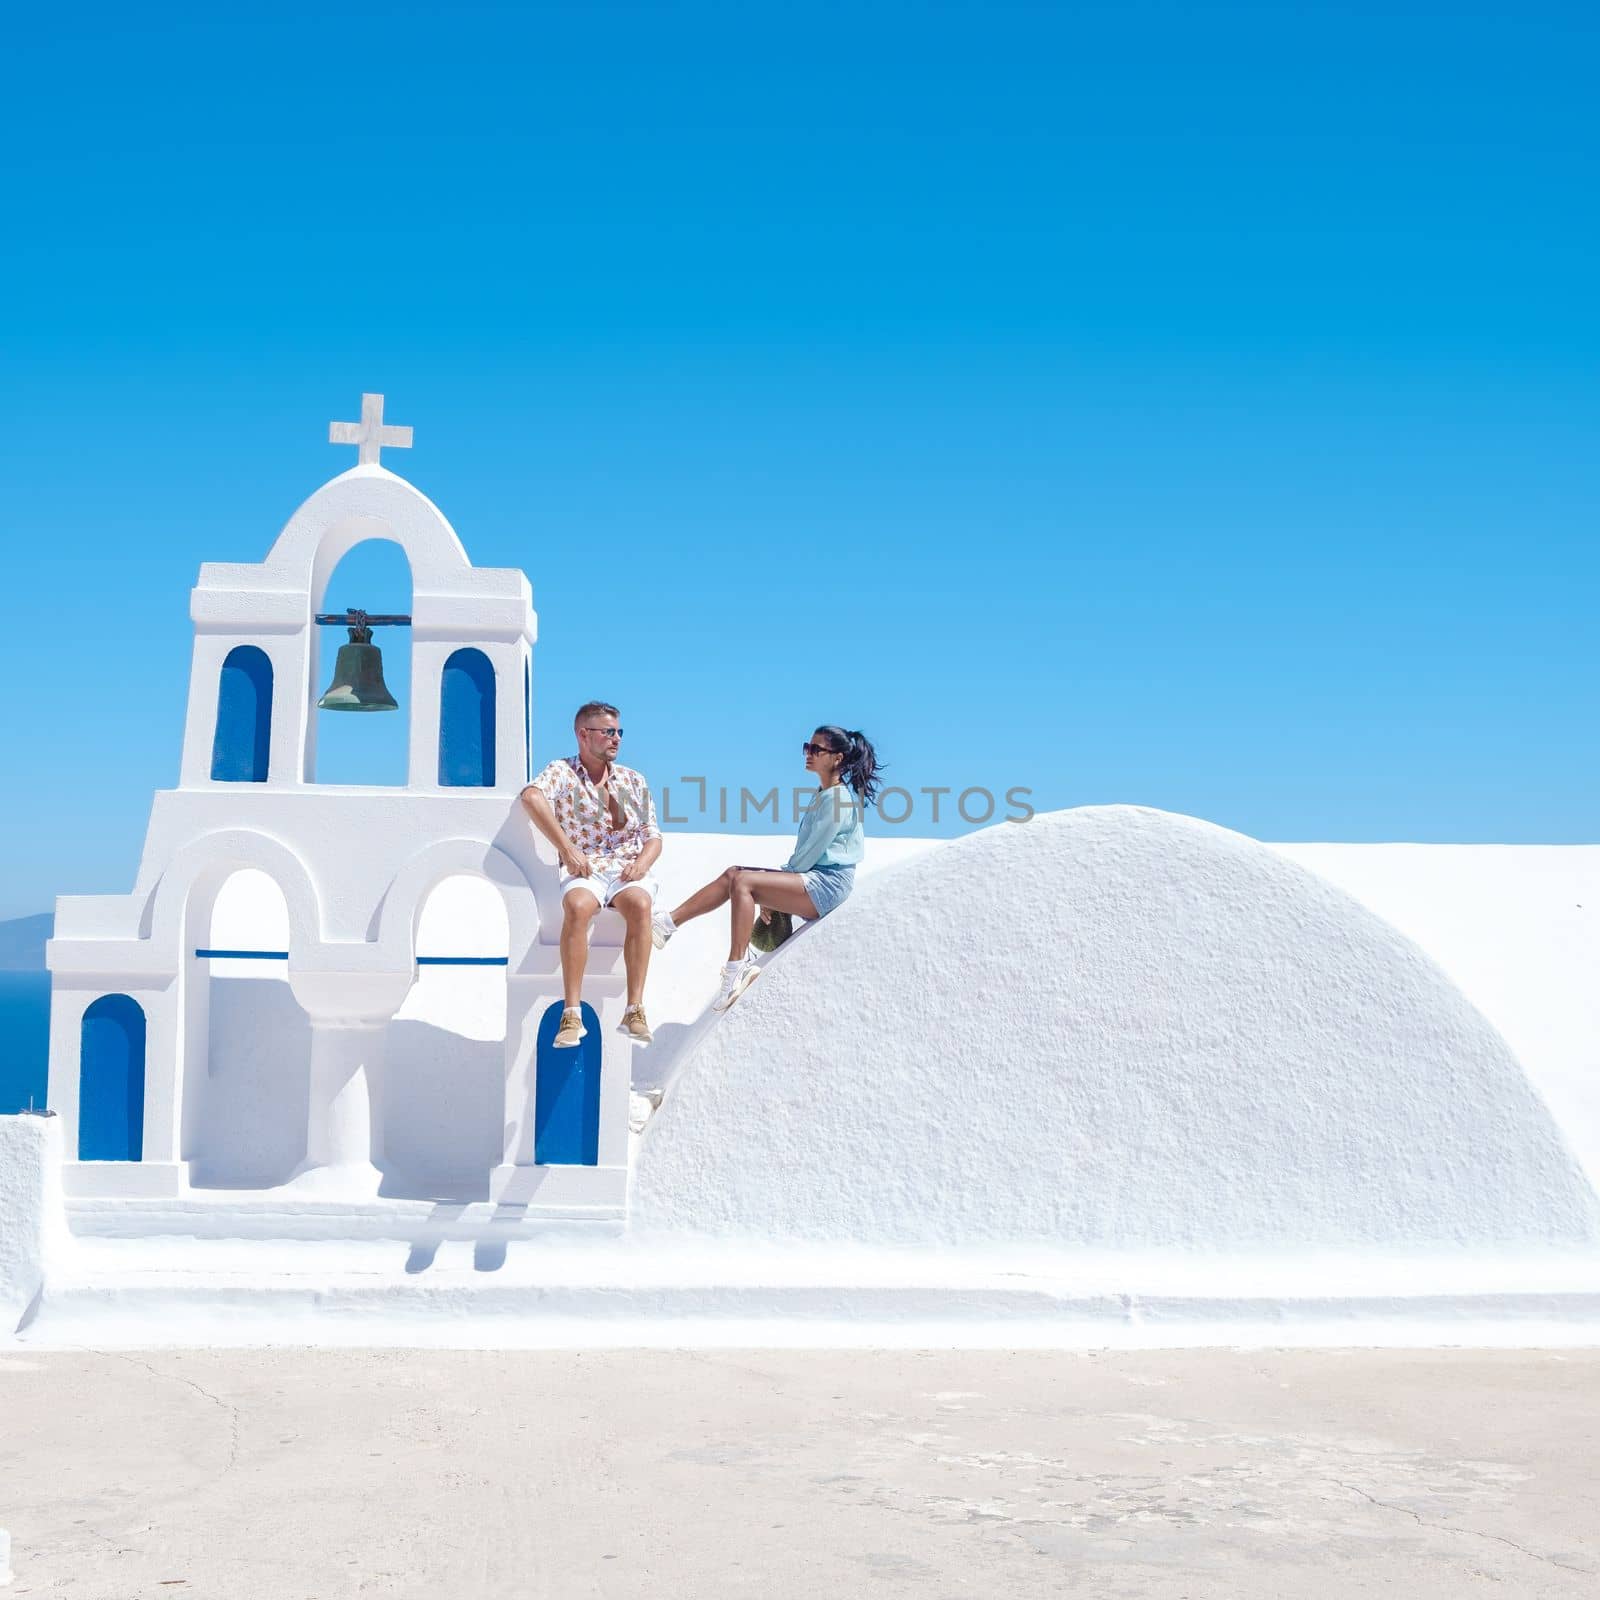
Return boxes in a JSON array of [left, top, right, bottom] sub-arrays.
[[653, 725, 878, 1011]]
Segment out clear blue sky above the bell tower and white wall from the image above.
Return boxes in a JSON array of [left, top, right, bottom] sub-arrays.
[[0, 3, 1600, 915]]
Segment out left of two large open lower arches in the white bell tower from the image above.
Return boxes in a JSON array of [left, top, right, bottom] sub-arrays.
[[181, 867, 310, 1189]]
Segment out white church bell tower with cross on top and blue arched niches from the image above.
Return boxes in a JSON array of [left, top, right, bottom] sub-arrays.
[[48, 395, 629, 1216]]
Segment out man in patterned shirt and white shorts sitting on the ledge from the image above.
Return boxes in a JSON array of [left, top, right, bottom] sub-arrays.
[[522, 701, 661, 1050]]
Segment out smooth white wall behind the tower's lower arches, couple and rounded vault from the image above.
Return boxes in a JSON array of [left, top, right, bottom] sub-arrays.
[[106, 824, 1600, 1228]]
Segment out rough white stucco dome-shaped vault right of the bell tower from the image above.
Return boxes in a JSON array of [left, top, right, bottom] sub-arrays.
[[632, 806, 1600, 1250]]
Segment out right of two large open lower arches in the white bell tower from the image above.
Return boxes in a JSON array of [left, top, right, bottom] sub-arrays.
[[381, 874, 510, 1200]]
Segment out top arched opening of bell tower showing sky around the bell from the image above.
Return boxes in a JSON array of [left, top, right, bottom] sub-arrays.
[[306, 538, 411, 787]]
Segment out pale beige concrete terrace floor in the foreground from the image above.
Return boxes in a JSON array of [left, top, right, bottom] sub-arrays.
[[0, 1349, 1600, 1600]]
